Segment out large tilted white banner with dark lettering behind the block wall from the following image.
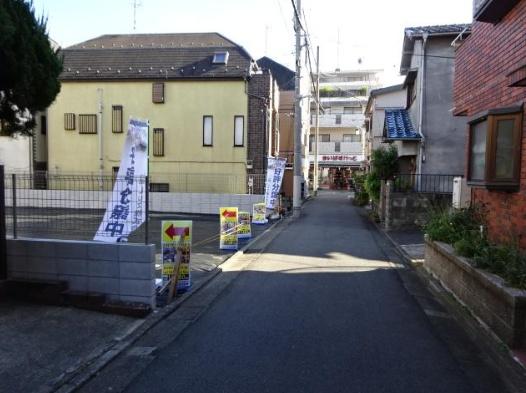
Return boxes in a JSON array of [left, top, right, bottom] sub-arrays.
[[93, 119, 149, 243]]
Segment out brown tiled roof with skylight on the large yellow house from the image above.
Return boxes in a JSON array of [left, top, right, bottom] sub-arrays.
[[61, 33, 257, 81]]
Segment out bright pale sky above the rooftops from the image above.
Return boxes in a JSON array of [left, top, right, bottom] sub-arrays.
[[33, 0, 478, 84]]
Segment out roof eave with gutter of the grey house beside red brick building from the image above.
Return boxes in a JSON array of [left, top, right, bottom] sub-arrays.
[[400, 23, 471, 75]]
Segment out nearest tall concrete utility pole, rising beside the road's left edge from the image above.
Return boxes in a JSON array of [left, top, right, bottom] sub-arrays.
[[292, 0, 303, 217]]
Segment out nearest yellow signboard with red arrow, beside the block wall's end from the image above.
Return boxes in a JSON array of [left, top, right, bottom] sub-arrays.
[[161, 221, 192, 292]]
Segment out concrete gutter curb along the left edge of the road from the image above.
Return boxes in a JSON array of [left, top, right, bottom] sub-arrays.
[[50, 218, 292, 393]]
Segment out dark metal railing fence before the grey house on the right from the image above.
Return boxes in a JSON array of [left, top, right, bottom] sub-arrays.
[[393, 174, 461, 194]]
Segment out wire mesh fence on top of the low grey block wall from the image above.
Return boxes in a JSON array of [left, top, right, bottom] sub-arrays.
[[4, 173, 149, 242]]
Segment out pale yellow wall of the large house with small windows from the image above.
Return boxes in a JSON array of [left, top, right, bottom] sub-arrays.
[[48, 81, 248, 192]]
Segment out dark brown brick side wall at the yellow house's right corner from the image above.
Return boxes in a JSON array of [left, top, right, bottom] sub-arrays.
[[247, 71, 272, 194]]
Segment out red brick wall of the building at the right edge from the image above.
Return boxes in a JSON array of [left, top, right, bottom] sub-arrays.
[[454, 0, 526, 248]]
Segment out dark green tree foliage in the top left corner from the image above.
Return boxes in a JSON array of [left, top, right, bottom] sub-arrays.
[[0, 0, 62, 135]]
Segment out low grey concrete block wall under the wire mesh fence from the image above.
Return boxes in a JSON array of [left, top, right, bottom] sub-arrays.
[[7, 238, 155, 308]]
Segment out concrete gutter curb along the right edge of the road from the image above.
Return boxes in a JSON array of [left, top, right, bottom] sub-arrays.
[[374, 217, 526, 393]]
